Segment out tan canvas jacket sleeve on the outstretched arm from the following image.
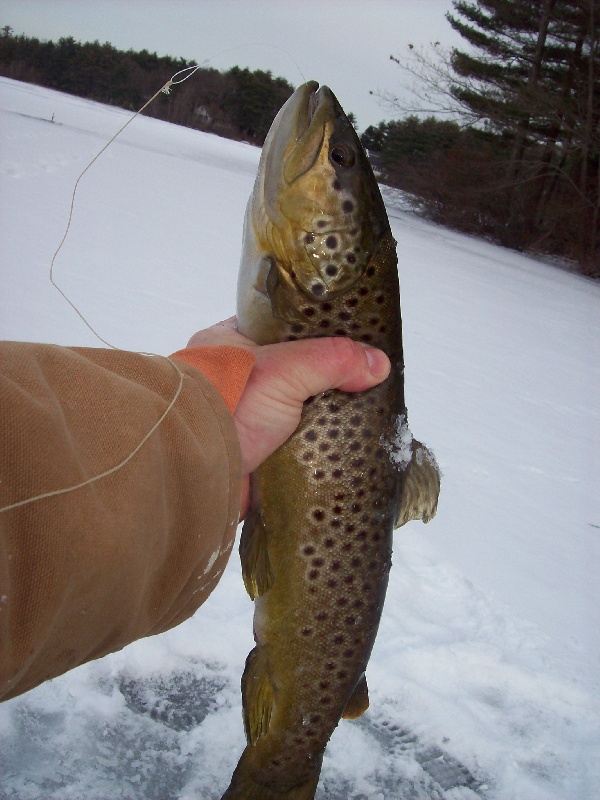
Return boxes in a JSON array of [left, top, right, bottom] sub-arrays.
[[0, 343, 253, 699]]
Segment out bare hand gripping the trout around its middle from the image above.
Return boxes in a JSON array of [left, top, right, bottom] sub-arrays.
[[188, 317, 390, 519]]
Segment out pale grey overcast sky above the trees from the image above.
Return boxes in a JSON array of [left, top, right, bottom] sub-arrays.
[[0, 0, 460, 130]]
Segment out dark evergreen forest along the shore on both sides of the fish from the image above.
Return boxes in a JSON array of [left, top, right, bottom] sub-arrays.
[[0, 0, 600, 278]]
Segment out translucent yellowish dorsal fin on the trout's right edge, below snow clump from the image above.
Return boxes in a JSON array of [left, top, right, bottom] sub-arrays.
[[395, 439, 440, 528]]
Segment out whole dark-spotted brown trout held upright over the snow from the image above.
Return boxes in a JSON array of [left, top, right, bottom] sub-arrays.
[[224, 82, 439, 800]]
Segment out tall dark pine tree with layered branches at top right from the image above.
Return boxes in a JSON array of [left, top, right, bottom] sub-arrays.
[[448, 0, 600, 268]]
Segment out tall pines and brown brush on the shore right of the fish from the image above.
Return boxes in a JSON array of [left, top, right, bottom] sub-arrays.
[[362, 0, 600, 276]]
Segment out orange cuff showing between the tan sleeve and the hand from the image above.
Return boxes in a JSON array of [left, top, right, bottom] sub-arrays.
[[171, 345, 256, 414]]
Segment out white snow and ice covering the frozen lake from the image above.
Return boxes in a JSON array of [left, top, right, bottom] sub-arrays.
[[0, 76, 600, 800]]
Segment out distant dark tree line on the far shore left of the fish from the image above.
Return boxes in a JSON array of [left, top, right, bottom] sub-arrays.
[[0, 26, 294, 145]]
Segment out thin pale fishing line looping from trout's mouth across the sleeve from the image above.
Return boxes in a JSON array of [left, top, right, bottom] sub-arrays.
[[0, 42, 306, 514]]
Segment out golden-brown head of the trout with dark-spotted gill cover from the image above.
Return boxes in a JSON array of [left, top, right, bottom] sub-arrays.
[[238, 81, 390, 334]]
